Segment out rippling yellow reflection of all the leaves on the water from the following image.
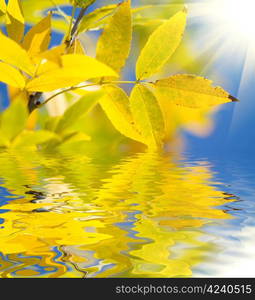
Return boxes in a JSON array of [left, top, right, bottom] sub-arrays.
[[0, 152, 236, 277]]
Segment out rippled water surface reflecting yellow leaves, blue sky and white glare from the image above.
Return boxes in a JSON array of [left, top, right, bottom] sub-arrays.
[[0, 152, 255, 277]]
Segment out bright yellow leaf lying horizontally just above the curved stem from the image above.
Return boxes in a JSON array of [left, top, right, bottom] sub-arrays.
[[27, 54, 117, 92]]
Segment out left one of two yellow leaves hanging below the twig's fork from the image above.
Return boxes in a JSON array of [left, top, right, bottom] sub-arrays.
[[100, 84, 143, 142]]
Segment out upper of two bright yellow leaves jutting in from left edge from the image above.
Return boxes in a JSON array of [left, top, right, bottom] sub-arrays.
[[0, 33, 35, 75]]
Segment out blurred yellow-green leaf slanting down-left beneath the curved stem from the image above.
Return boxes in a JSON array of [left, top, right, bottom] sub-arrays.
[[55, 90, 104, 133]]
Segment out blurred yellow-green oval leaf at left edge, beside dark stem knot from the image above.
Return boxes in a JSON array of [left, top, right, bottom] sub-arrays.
[[0, 100, 28, 141]]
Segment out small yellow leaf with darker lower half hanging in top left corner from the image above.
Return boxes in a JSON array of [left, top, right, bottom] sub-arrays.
[[6, 0, 25, 42]]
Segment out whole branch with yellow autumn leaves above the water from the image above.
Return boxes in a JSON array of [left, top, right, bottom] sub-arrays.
[[0, 0, 237, 151]]
